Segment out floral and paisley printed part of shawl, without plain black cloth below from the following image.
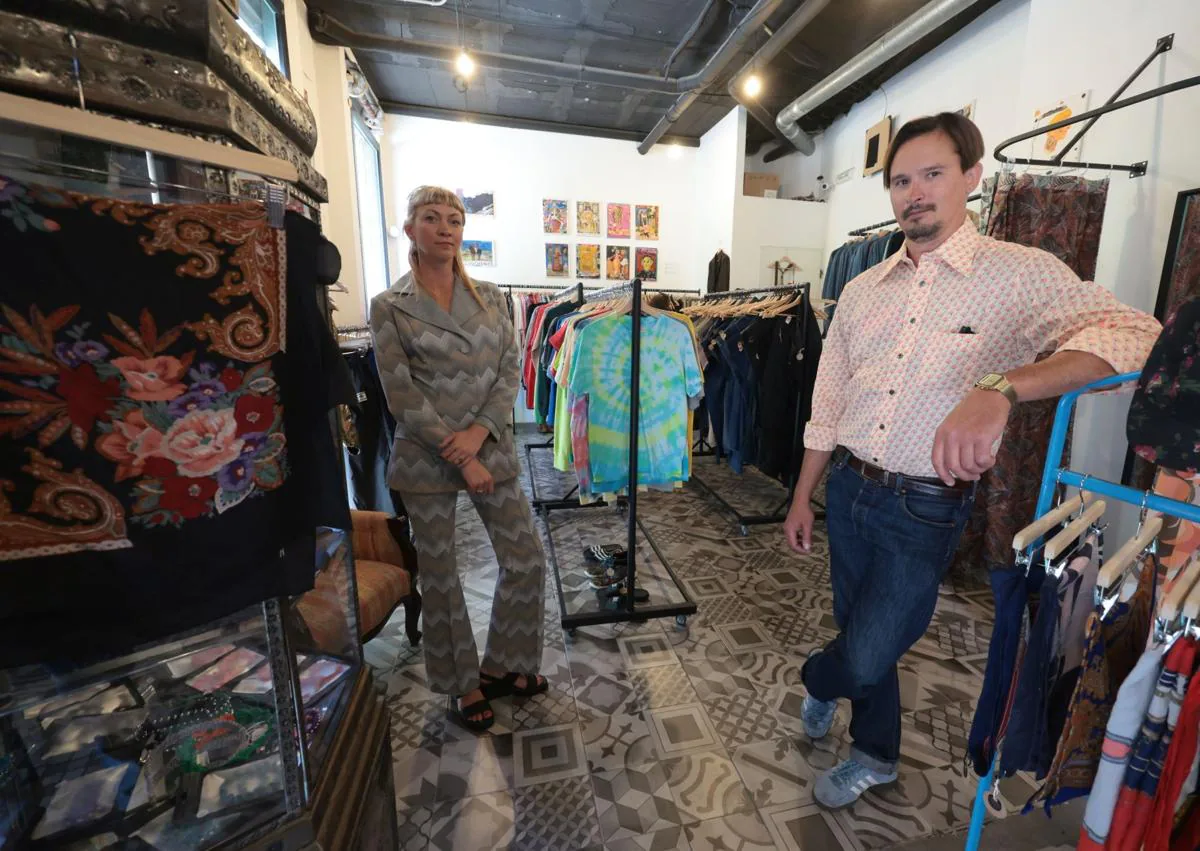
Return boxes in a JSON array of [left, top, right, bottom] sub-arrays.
[[0, 178, 287, 562]]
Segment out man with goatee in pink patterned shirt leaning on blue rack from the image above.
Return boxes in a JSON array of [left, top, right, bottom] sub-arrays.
[[784, 113, 1159, 807]]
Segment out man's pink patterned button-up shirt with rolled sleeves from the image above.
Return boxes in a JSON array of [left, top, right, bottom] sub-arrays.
[[804, 220, 1160, 477]]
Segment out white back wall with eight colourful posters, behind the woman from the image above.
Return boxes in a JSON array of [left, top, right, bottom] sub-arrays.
[[383, 115, 713, 298]]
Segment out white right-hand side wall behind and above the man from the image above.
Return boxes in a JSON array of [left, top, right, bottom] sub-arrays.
[[750, 0, 1200, 540]]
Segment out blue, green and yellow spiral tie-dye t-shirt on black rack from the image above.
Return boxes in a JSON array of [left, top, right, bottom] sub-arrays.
[[569, 316, 703, 492]]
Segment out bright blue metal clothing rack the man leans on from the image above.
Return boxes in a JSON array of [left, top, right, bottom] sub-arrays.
[[966, 372, 1200, 851]]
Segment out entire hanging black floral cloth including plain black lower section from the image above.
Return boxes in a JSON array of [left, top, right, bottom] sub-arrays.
[[0, 178, 328, 667]]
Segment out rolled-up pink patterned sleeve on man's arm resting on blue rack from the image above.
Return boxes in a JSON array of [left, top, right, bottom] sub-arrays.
[[1027, 252, 1162, 374]]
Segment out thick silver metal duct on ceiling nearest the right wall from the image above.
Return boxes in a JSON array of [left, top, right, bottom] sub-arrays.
[[764, 0, 979, 153]]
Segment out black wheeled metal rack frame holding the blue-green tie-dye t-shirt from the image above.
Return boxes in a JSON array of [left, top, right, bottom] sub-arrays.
[[540, 278, 696, 635]]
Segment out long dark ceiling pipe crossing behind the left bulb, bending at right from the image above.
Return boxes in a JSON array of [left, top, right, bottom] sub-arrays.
[[308, 6, 782, 95]]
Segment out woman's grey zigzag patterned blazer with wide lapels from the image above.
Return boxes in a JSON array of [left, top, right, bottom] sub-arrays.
[[371, 274, 521, 493]]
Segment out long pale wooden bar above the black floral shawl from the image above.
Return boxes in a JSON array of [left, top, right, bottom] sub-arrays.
[[0, 92, 300, 184]]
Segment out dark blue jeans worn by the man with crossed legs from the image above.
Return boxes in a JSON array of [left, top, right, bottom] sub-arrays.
[[803, 454, 974, 773]]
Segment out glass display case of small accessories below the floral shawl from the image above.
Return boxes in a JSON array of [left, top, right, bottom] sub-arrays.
[[0, 529, 364, 851]]
